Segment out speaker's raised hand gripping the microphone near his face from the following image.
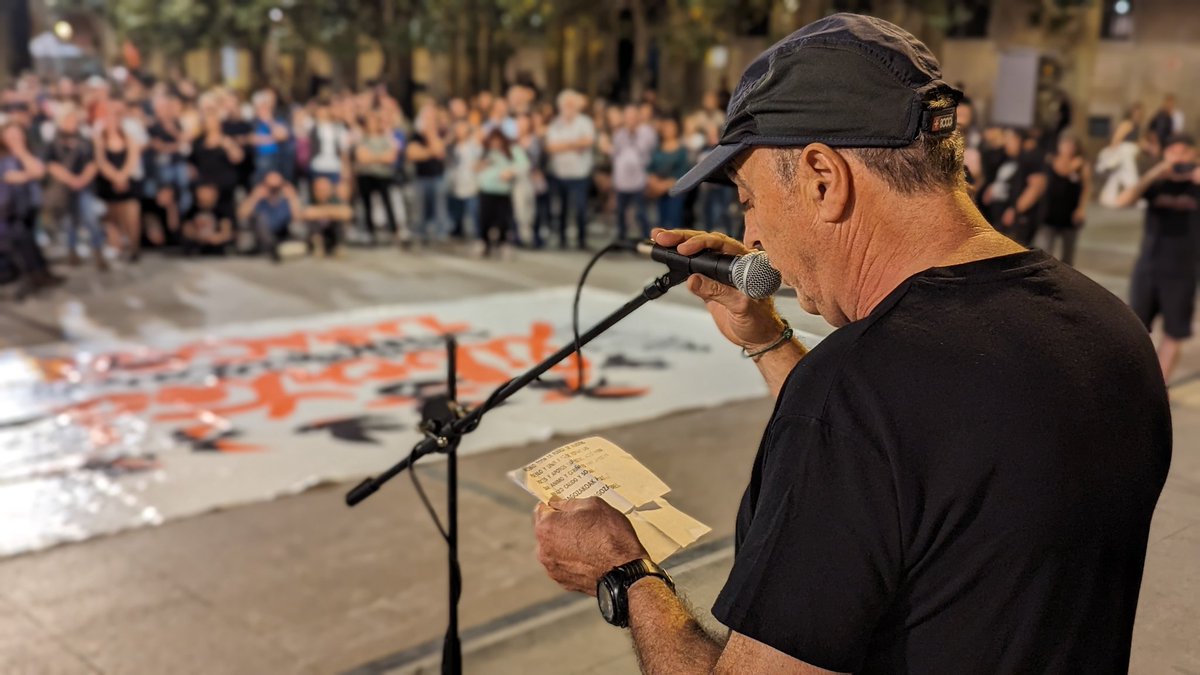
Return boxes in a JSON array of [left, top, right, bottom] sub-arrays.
[[650, 228, 784, 351]]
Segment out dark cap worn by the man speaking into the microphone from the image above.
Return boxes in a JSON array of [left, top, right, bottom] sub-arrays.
[[671, 13, 962, 195]]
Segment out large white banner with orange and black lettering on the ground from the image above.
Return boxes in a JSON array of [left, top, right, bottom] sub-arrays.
[[0, 288, 767, 555]]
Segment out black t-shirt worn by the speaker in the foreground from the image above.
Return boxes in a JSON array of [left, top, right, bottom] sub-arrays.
[[713, 251, 1171, 675]]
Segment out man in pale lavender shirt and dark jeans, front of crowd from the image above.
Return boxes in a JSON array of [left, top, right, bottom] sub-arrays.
[[608, 104, 658, 240]]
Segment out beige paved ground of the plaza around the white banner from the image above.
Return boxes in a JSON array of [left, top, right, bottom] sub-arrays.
[[0, 207, 1200, 675]]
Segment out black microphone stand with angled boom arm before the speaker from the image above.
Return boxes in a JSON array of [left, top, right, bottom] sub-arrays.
[[346, 269, 689, 675]]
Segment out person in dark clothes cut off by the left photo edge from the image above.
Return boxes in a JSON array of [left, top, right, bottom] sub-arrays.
[[0, 123, 62, 300]]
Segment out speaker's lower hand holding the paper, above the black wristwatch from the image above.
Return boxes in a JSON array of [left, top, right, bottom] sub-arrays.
[[534, 497, 649, 596]]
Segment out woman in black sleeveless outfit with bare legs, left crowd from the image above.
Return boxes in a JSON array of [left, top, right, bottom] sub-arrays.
[[92, 103, 142, 262]]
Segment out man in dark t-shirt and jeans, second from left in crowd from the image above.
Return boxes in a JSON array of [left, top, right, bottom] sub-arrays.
[[46, 104, 108, 271]]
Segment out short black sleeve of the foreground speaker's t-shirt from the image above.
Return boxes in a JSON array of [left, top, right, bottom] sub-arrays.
[[713, 416, 902, 673]]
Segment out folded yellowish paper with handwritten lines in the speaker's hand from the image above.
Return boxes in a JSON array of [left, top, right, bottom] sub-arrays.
[[509, 436, 712, 562]]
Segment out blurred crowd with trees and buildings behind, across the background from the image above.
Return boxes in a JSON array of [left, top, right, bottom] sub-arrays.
[[0, 0, 1200, 298]]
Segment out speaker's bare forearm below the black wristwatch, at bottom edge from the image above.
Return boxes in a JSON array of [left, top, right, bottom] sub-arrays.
[[629, 577, 724, 675]]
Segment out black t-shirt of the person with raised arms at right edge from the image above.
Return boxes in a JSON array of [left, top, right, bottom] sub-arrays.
[[1138, 180, 1200, 279]]
